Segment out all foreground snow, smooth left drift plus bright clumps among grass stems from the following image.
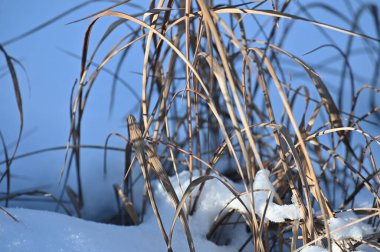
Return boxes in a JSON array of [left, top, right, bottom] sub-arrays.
[[0, 170, 373, 252]]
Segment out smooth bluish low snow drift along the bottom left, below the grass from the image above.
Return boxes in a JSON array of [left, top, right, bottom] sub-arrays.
[[0, 208, 235, 252]]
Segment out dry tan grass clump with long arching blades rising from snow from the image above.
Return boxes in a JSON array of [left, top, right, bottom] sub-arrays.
[[0, 0, 380, 251]]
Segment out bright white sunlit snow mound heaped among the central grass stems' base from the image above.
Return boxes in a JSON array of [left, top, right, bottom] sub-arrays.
[[156, 170, 302, 225]]
